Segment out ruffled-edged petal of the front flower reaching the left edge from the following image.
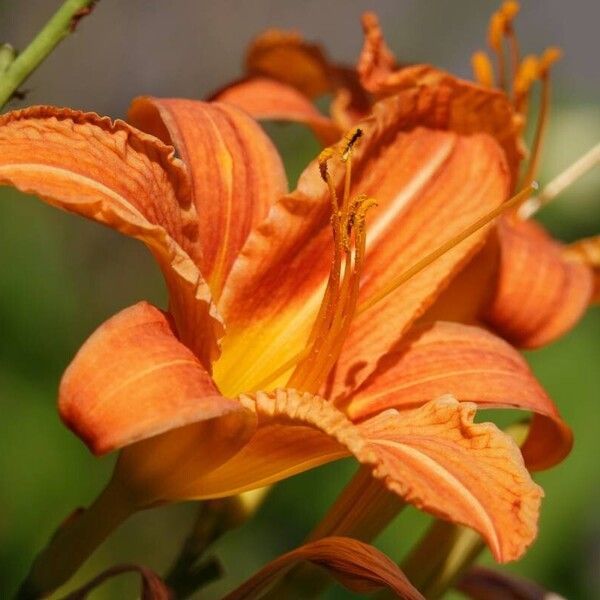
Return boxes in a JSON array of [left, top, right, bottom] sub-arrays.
[[0, 106, 222, 367]]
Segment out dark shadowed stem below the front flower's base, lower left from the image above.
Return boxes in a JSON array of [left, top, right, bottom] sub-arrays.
[[16, 479, 137, 600]]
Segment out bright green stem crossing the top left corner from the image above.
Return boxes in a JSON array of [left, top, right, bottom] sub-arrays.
[[0, 0, 97, 108]]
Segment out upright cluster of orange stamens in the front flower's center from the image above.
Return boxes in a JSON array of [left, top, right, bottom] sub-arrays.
[[287, 129, 376, 393]]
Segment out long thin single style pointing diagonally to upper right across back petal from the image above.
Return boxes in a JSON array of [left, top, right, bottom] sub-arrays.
[[356, 182, 538, 315]]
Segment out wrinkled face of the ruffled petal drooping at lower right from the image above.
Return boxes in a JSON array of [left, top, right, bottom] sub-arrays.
[[359, 397, 543, 562]]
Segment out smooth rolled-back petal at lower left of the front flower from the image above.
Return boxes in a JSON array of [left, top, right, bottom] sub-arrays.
[[59, 302, 251, 454]]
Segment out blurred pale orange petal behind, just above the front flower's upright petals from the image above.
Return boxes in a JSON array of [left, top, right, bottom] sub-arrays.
[[214, 77, 342, 145]]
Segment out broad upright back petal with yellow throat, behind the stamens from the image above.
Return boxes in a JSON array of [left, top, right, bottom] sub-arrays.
[[215, 88, 508, 395]]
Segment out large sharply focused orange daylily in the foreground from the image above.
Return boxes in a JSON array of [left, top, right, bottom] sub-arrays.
[[0, 86, 571, 589]]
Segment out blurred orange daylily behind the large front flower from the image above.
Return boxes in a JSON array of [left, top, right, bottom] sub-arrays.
[[214, 2, 597, 348]]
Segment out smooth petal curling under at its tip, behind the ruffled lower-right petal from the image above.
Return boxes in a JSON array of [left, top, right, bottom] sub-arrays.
[[332, 321, 573, 469]]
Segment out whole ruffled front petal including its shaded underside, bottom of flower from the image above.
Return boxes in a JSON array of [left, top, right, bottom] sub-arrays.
[[182, 390, 541, 561]]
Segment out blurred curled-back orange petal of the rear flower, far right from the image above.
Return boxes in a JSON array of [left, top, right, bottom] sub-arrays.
[[486, 218, 593, 348]]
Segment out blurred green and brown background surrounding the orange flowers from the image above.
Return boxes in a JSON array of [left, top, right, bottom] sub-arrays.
[[0, 0, 600, 599]]
